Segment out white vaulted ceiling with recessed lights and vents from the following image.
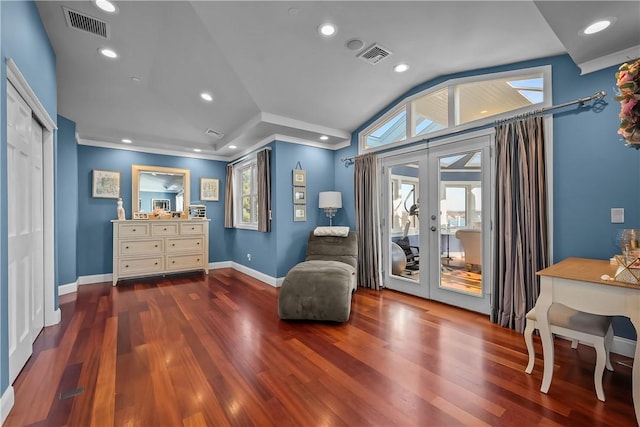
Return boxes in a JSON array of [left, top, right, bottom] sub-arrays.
[[37, 0, 640, 159]]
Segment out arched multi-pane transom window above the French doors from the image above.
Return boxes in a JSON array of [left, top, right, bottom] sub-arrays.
[[358, 66, 551, 152]]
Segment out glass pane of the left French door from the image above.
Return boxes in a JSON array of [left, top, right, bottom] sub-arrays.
[[389, 163, 420, 282]]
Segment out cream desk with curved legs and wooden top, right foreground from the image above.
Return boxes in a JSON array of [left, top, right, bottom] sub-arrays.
[[536, 258, 640, 424]]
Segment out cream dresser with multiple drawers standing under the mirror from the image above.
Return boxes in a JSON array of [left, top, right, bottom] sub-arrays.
[[111, 219, 209, 286]]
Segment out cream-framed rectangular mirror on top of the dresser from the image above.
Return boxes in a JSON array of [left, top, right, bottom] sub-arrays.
[[131, 165, 191, 217]]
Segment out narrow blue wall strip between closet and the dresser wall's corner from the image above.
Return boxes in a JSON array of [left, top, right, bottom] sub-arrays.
[[54, 116, 78, 286]]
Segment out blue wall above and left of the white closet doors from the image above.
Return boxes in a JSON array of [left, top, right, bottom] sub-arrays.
[[0, 1, 57, 404]]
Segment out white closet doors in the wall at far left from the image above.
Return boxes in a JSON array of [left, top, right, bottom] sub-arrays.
[[7, 82, 44, 382]]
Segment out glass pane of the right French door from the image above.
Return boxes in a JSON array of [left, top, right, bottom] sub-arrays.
[[438, 151, 483, 296]]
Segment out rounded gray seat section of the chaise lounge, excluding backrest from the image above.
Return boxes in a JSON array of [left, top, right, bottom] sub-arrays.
[[278, 261, 356, 322]]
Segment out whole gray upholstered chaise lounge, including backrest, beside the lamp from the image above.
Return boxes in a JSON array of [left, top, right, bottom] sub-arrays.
[[278, 231, 358, 322]]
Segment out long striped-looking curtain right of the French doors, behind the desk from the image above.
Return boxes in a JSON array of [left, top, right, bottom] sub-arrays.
[[491, 117, 549, 332]]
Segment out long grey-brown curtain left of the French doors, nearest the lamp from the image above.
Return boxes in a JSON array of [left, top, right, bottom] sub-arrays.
[[354, 154, 382, 290]]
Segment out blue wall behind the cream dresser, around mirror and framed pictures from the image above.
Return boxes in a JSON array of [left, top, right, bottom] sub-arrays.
[[77, 145, 229, 276]]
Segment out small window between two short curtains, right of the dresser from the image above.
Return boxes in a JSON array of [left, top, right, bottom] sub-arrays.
[[233, 158, 258, 230]]
